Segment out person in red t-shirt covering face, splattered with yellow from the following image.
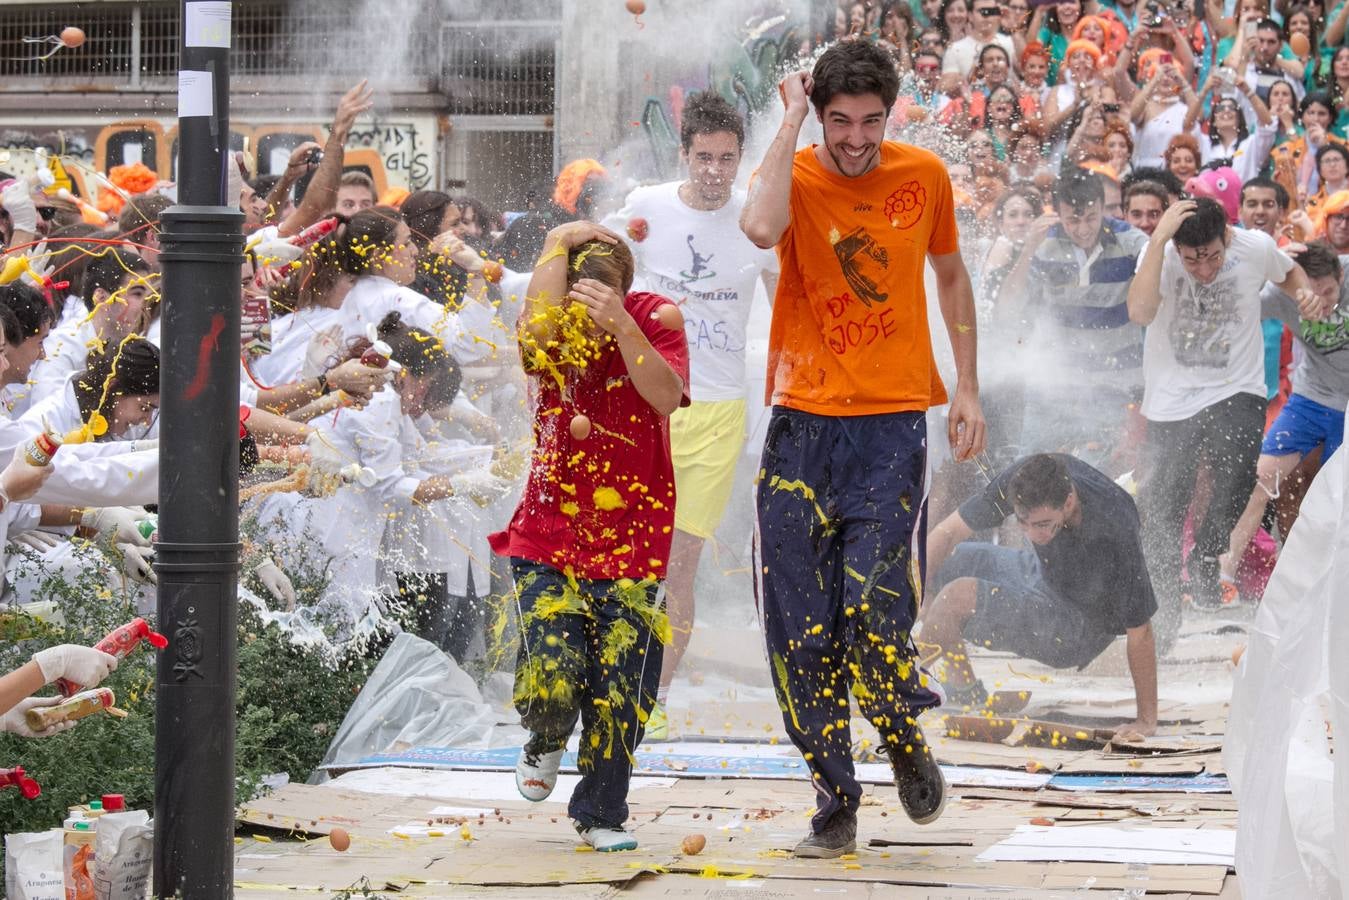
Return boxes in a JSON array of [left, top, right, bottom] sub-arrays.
[[490, 221, 689, 850]]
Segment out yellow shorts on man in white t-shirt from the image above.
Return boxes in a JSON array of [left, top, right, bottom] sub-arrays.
[[670, 399, 745, 540]]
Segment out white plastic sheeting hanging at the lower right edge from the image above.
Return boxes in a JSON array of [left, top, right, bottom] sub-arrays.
[[1224, 449, 1349, 900]]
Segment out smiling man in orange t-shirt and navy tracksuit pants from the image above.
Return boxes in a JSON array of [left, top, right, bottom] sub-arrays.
[[741, 40, 983, 858]]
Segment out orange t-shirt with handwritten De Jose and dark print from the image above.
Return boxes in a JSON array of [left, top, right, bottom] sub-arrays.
[[765, 140, 974, 416]]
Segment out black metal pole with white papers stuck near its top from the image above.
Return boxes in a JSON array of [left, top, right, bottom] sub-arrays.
[[154, 0, 243, 900]]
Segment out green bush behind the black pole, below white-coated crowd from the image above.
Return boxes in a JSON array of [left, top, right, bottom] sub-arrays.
[[0, 546, 390, 890]]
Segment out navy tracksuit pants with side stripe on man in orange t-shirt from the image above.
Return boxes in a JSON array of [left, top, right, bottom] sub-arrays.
[[757, 406, 940, 831]]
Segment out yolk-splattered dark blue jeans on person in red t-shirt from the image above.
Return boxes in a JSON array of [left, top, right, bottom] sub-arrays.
[[511, 559, 669, 828]]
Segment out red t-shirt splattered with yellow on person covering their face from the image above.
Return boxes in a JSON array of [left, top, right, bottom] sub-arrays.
[[487, 293, 689, 580]]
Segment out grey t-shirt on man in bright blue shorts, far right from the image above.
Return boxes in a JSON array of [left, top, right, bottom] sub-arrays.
[[1260, 256, 1349, 410]]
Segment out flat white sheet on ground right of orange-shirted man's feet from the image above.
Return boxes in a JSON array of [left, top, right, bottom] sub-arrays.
[[975, 824, 1237, 866]]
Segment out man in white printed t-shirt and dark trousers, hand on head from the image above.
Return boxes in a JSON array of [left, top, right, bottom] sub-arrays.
[[1128, 198, 1318, 646]]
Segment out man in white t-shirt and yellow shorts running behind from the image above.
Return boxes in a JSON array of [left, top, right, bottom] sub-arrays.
[[604, 92, 777, 741]]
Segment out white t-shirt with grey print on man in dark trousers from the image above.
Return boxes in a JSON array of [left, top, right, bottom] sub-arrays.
[[1139, 228, 1294, 422]]
